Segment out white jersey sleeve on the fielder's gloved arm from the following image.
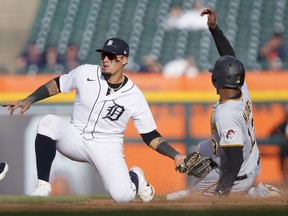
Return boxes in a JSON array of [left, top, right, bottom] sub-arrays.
[[132, 92, 157, 134]]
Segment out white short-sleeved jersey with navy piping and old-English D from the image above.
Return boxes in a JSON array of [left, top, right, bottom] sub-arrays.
[[60, 64, 156, 139]]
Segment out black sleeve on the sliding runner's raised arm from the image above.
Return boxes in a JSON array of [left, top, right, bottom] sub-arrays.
[[209, 25, 235, 57]]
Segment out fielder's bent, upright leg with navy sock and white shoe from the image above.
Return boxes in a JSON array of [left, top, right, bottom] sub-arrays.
[[32, 115, 85, 196]]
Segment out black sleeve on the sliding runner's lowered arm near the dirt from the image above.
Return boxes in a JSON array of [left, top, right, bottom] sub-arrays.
[[215, 146, 243, 196]]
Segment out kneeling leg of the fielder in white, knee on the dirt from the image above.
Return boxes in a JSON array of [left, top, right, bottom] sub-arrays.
[[87, 139, 154, 202]]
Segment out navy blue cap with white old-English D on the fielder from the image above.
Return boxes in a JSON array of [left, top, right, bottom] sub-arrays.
[[95, 38, 129, 57]]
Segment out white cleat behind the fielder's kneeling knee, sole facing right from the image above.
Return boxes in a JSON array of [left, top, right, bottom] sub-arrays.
[[130, 166, 155, 202]]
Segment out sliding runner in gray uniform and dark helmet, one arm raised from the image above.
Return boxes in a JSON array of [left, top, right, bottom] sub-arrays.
[[187, 9, 278, 197]]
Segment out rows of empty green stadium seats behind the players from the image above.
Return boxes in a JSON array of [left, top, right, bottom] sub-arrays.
[[26, 0, 288, 71]]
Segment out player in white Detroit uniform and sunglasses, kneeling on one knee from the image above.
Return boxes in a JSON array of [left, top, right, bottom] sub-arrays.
[[3, 38, 185, 202]]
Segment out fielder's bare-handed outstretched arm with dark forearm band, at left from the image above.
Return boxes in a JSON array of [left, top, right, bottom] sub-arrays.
[[2, 77, 60, 115]]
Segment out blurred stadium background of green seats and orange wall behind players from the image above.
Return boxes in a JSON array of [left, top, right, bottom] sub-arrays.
[[0, 0, 288, 195]]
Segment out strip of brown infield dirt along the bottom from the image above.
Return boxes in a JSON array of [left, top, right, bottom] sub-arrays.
[[0, 190, 288, 216]]
